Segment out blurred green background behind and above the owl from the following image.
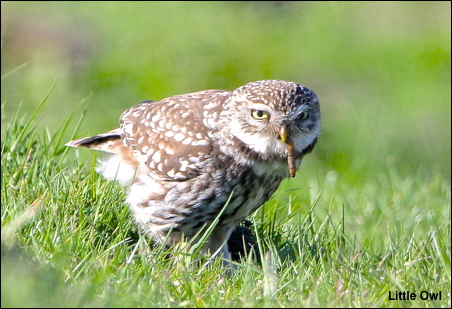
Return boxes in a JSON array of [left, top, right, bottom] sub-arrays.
[[1, 1, 451, 306]]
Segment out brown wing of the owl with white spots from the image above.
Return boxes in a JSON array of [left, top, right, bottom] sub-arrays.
[[120, 90, 227, 181]]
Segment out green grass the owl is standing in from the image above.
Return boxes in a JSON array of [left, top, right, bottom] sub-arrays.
[[1, 99, 451, 307]]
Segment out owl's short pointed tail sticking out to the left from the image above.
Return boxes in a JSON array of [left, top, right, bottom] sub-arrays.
[[66, 129, 123, 153]]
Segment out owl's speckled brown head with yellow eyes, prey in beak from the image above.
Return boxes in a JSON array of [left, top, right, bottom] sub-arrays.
[[223, 80, 320, 176]]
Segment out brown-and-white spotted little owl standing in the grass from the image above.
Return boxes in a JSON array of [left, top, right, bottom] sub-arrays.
[[66, 80, 320, 259]]
